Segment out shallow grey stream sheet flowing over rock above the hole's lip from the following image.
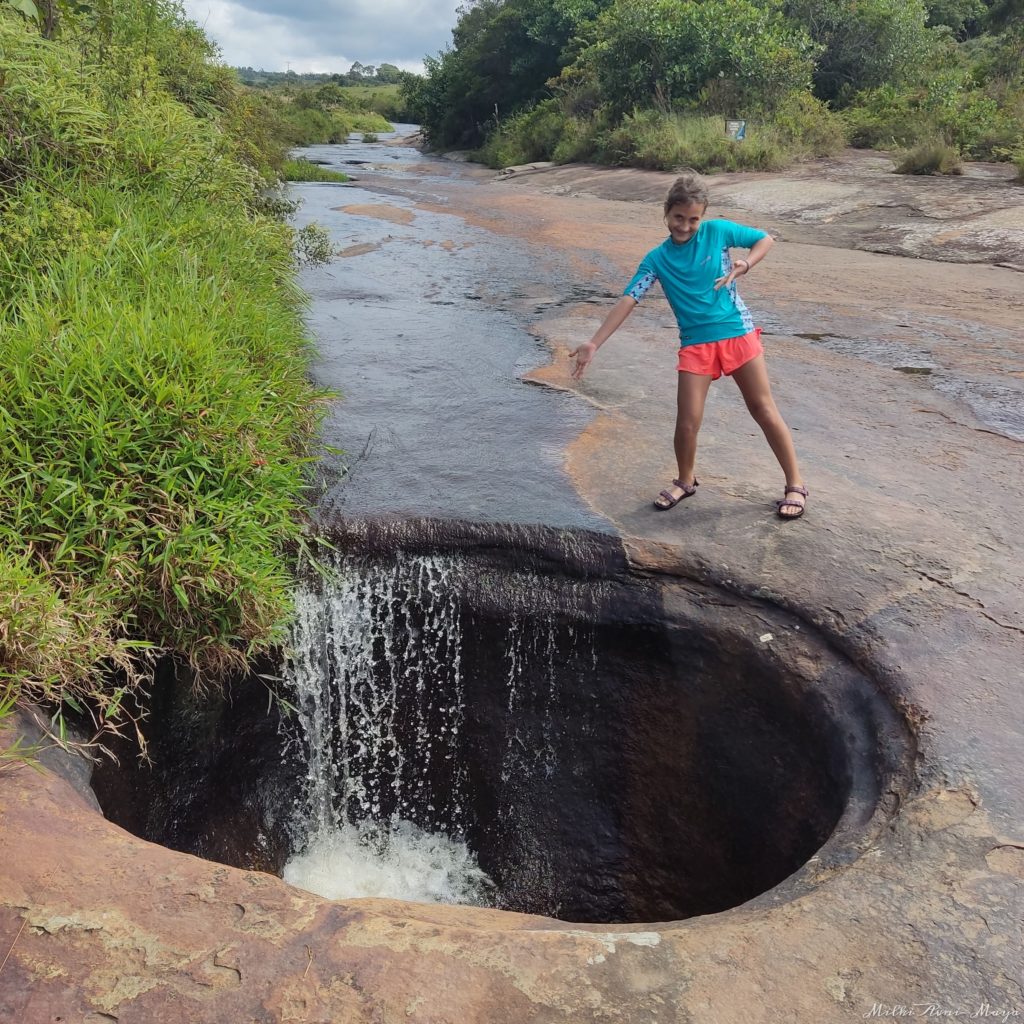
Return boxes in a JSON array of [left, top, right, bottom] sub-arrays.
[[295, 128, 609, 531]]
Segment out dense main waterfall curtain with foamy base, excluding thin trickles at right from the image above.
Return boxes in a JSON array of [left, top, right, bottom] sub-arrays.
[[285, 553, 488, 903]]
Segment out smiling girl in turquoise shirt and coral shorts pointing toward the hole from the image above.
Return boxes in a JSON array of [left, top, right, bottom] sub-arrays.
[[569, 174, 808, 519]]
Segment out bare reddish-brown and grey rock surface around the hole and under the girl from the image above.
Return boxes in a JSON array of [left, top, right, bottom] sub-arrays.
[[0, 155, 1024, 1024]]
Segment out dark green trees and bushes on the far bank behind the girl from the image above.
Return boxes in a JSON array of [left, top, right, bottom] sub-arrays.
[[400, 0, 1024, 173]]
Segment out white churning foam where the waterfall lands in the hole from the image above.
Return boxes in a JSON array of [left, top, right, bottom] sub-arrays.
[[284, 821, 494, 906]]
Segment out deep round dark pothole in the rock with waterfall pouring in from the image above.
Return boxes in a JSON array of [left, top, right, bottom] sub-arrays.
[[93, 523, 905, 923]]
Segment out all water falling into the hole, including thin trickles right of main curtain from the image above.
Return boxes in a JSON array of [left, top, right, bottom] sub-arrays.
[[284, 552, 593, 905]]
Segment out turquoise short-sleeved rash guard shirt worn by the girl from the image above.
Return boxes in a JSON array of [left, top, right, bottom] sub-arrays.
[[623, 220, 767, 348]]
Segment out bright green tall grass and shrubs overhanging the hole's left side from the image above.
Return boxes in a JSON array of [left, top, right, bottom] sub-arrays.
[[0, 6, 327, 753]]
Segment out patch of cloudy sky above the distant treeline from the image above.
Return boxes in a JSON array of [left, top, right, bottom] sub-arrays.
[[184, 0, 463, 72]]
